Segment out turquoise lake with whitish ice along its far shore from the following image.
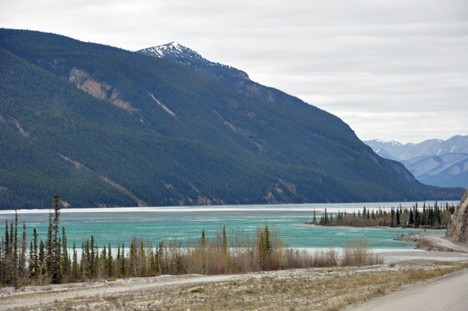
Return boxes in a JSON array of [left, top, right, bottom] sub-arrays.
[[0, 201, 459, 251]]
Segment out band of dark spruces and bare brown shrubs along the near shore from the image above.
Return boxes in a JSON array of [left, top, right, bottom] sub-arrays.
[[0, 201, 381, 288]]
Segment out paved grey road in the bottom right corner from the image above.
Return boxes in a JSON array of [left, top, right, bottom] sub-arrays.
[[346, 269, 468, 311]]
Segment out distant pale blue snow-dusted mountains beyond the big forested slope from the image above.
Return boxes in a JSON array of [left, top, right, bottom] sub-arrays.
[[364, 135, 468, 188]]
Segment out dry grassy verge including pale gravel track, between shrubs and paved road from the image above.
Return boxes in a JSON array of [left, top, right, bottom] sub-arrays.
[[0, 261, 467, 311]]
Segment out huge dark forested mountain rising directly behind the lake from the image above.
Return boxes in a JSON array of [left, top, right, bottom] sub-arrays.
[[0, 29, 463, 209]]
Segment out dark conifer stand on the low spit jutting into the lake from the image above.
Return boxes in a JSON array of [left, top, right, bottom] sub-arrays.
[[305, 201, 457, 229]]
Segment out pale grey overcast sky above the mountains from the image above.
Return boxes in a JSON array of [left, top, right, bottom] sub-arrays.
[[0, 0, 468, 143]]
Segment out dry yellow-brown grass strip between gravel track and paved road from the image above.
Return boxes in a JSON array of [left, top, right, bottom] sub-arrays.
[[6, 262, 468, 311]]
